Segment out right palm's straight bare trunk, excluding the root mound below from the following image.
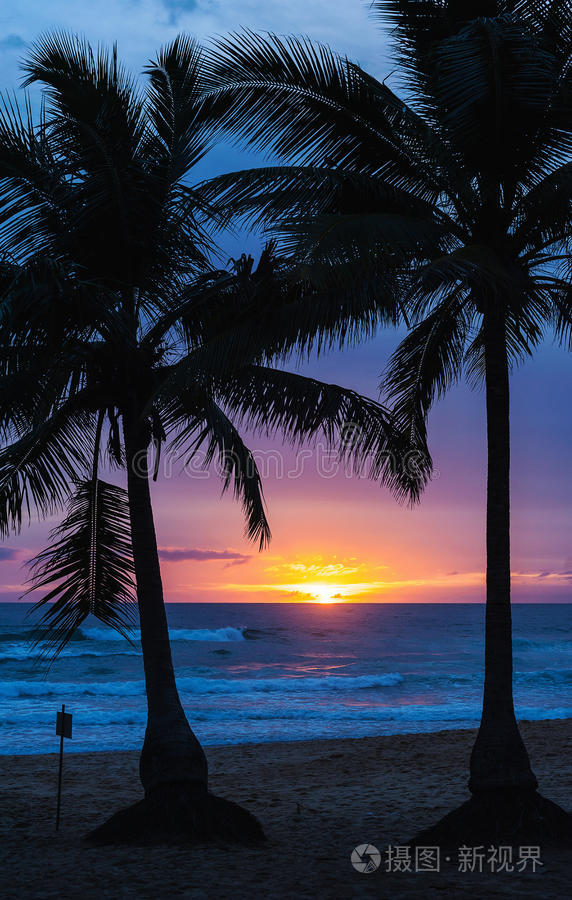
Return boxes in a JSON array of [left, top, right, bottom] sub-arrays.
[[469, 310, 537, 793]]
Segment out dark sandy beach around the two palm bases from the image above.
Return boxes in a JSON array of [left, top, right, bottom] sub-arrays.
[[0, 720, 572, 900]]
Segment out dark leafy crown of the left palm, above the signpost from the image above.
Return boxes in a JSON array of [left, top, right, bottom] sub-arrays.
[[0, 35, 414, 636]]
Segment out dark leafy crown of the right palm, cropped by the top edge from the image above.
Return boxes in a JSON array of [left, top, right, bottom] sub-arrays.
[[202, 0, 572, 380]]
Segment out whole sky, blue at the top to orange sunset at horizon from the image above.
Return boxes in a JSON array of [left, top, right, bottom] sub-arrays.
[[0, 0, 572, 603]]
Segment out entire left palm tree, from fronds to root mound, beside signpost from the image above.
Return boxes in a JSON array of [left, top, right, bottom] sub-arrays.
[[0, 35, 414, 842]]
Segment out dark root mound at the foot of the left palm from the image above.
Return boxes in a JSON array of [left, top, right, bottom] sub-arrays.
[[86, 783, 265, 846]]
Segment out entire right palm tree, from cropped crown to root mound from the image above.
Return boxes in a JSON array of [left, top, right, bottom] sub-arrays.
[[203, 0, 572, 844]]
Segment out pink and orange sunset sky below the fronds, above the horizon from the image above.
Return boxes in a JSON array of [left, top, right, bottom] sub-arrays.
[[0, 334, 572, 602]]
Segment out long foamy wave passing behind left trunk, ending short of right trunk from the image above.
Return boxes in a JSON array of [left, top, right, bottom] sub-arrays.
[[0, 672, 403, 697]]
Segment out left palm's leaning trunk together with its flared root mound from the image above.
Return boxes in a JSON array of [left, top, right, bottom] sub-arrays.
[[89, 405, 264, 844]]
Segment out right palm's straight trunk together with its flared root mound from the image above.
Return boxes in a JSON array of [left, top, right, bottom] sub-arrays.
[[413, 310, 572, 848]]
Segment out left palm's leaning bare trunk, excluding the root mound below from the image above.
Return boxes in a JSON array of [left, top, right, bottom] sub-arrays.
[[123, 411, 207, 795]]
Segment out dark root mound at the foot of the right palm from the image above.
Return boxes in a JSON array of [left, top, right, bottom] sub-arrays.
[[410, 788, 572, 848]]
